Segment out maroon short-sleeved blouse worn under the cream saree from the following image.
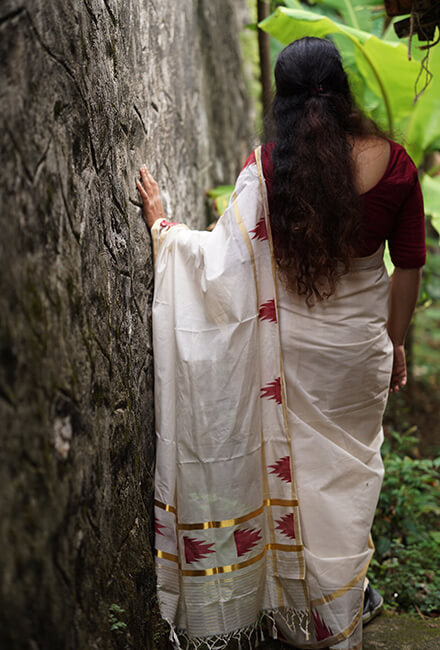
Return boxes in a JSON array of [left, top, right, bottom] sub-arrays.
[[244, 140, 426, 269]]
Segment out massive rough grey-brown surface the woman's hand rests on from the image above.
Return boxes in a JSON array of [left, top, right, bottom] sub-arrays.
[[0, 0, 253, 650]]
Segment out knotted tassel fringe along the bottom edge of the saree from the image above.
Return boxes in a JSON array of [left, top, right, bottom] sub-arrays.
[[167, 609, 310, 650]]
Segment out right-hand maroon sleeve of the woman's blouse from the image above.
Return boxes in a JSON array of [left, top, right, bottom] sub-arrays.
[[388, 170, 426, 269]]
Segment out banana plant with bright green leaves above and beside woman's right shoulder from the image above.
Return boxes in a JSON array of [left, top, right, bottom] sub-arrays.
[[259, 0, 440, 238]]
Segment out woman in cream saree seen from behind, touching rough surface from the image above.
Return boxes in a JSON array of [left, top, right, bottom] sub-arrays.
[[137, 38, 425, 650]]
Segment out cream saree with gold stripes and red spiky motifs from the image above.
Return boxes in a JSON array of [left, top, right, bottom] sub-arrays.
[[152, 150, 392, 650]]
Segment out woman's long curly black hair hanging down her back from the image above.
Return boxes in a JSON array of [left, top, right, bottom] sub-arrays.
[[269, 37, 381, 305]]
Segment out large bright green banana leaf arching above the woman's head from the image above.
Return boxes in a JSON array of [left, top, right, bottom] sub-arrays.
[[259, 6, 440, 164]]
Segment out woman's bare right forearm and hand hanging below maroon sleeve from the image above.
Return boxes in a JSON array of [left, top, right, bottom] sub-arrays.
[[387, 267, 422, 393]]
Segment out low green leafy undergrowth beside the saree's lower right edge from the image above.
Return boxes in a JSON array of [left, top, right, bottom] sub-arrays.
[[369, 431, 440, 614]]
